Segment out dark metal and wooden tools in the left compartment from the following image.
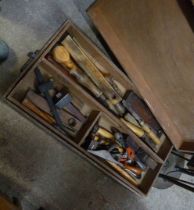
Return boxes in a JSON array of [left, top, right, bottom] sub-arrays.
[[22, 68, 86, 136]]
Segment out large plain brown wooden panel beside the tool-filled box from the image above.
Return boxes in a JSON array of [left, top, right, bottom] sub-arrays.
[[88, 0, 194, 150]]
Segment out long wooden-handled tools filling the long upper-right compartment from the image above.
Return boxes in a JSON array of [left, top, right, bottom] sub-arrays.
[[48, 35, 166, 152]]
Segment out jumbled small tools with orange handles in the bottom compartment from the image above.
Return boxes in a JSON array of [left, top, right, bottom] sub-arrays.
[[83, 124, 157, 186]]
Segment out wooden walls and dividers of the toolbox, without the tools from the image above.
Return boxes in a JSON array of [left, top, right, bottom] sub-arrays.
[[5, 21, 172, 196]]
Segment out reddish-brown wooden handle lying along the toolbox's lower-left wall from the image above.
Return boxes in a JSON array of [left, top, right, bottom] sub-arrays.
[[22, 98, 55, 125]]
